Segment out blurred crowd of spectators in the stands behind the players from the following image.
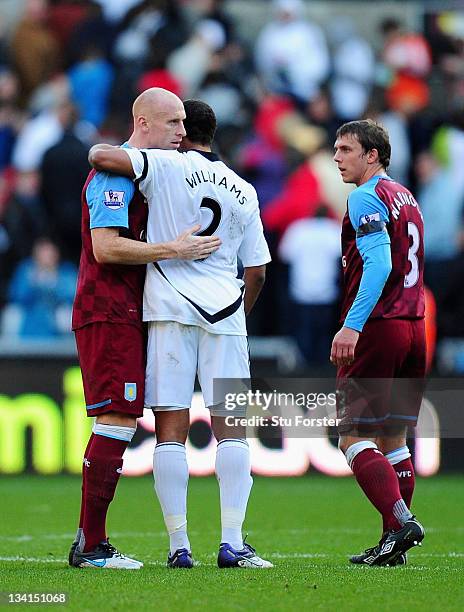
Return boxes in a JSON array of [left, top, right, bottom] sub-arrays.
[[0, 0, 464, 367]]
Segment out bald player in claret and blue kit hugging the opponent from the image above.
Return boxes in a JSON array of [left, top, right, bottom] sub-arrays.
[[69, 88, 220, 569]]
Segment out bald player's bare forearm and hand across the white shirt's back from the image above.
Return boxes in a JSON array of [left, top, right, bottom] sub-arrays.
[[91, 225, 221, 265]]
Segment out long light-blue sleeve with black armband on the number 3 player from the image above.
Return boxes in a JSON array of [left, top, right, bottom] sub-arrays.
[[344, 177, 392, 332]]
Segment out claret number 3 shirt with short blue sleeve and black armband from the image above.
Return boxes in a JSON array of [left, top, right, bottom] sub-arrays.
[[341, 175, 425, 328]]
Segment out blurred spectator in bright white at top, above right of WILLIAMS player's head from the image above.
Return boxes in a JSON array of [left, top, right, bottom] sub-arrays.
[[255, 0, 330, 104]]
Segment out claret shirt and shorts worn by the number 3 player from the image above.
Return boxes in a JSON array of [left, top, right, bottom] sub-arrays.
[[337, 174, 426, 435]]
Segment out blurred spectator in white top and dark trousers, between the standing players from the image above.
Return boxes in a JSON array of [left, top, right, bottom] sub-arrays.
[[279, 206, 340, 367]]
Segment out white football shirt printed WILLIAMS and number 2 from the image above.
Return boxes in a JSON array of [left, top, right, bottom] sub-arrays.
[[124, 149, 271, 335]]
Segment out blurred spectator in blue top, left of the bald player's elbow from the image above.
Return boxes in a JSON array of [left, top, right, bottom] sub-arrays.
[[9, 238, 77, 339]]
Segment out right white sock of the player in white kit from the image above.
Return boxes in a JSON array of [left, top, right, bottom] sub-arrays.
[[216, 439, 253, 550]]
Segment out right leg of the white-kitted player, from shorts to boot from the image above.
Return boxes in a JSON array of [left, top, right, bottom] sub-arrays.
[[198, 330, 272, 568]]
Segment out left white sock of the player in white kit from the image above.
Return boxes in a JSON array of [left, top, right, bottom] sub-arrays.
[[153, 442, 190, 554]]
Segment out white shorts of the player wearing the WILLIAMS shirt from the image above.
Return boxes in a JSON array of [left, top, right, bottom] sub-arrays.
[[145, 321, 250, 416]]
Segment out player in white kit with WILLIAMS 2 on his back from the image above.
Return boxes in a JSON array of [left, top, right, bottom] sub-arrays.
[[89, 94, 272, 568]]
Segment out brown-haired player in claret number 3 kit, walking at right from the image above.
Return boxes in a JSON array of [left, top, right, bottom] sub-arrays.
[[330, 120, 426, 565]]
